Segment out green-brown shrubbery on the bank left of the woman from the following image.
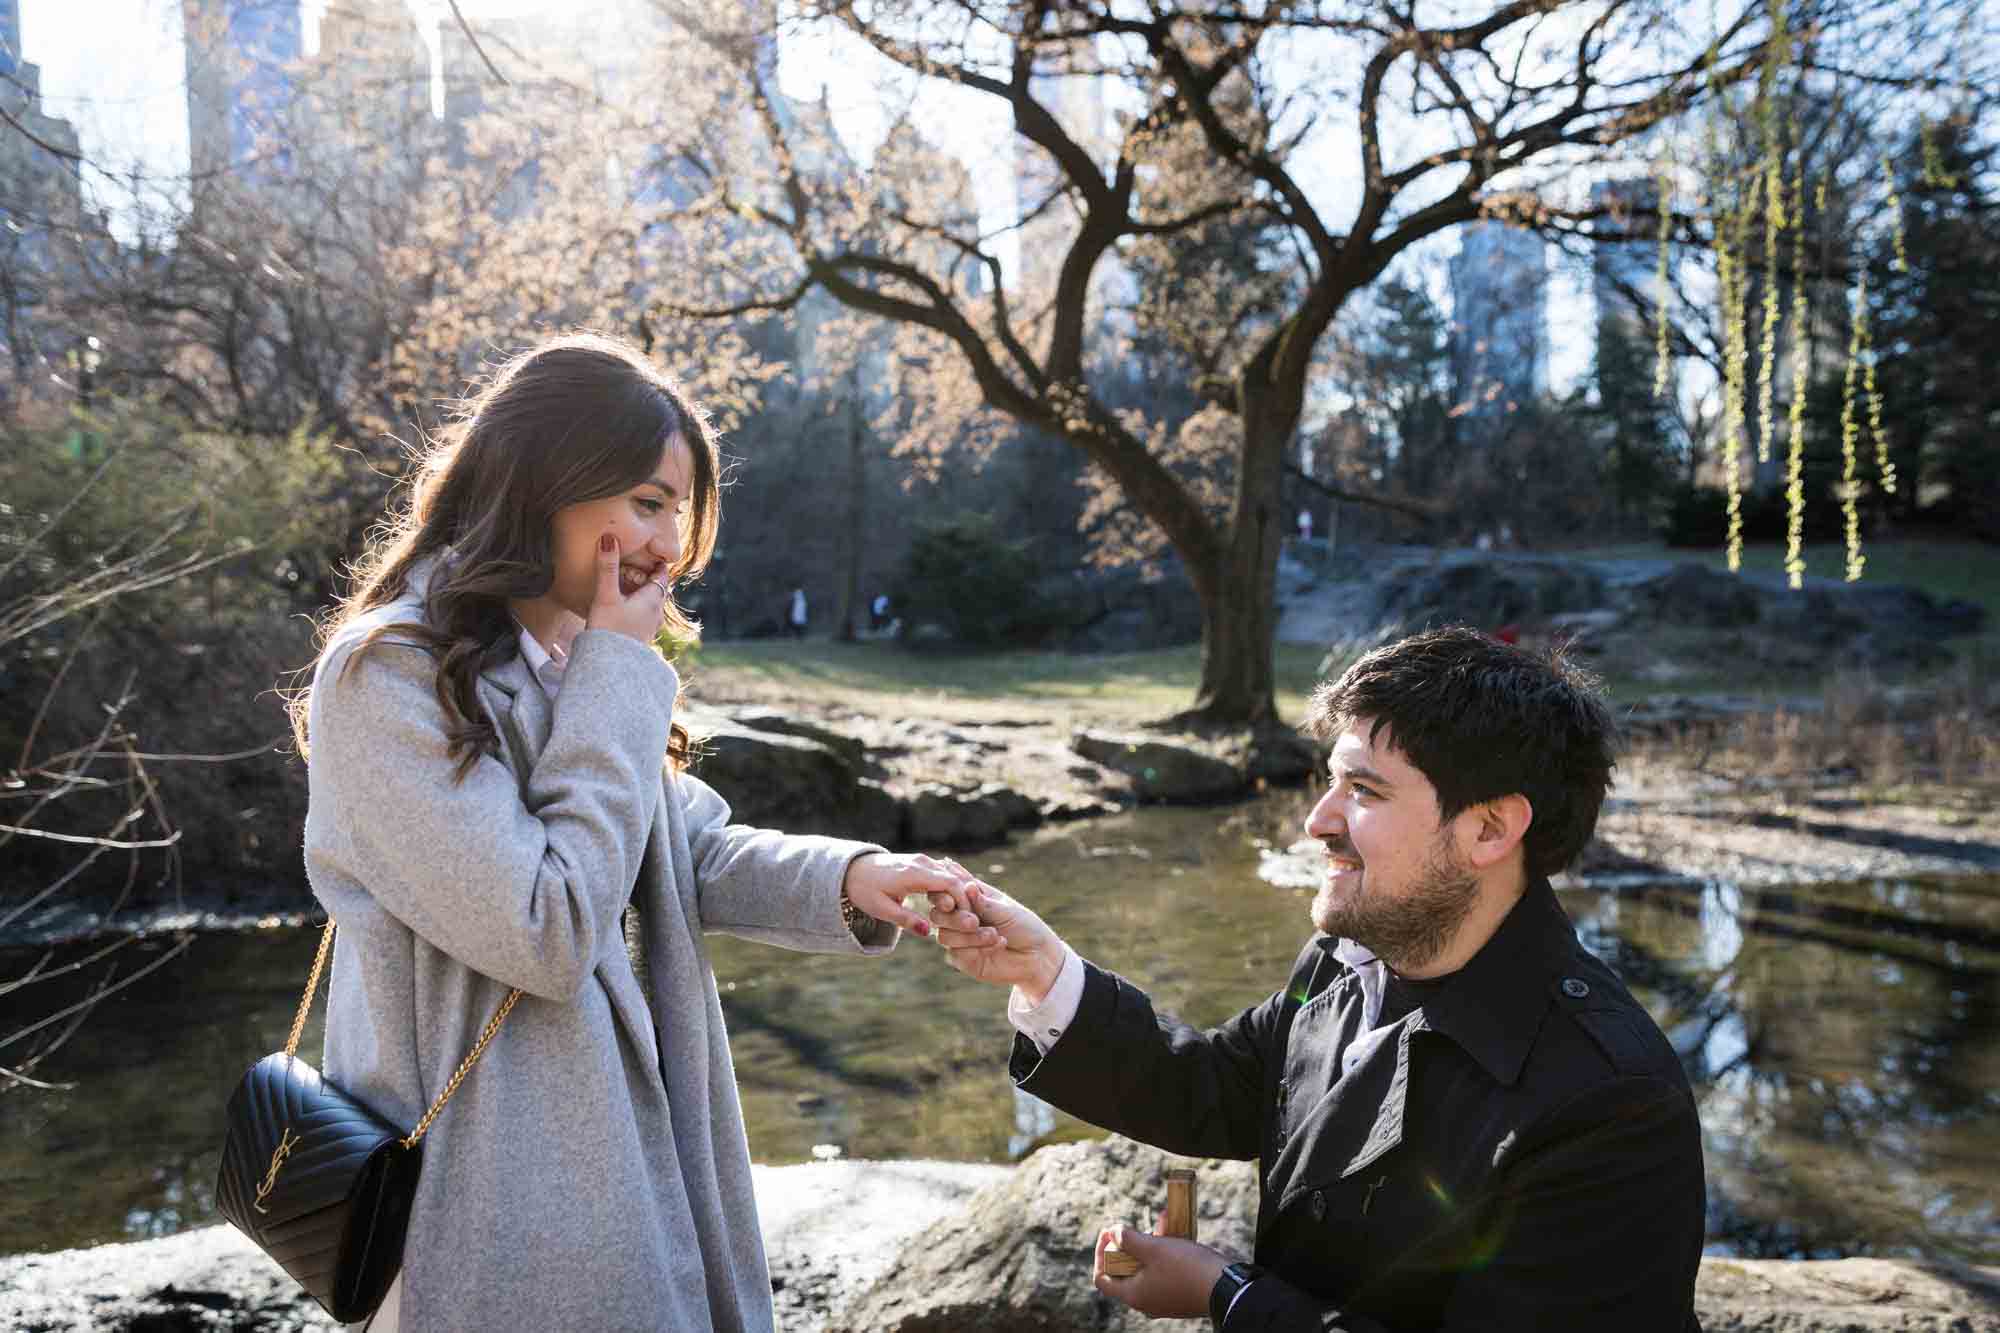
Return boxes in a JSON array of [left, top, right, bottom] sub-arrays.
[[0, 402, 362, 899]]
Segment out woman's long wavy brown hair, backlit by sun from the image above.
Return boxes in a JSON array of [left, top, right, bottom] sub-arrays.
[[288, 334, 720, 781]]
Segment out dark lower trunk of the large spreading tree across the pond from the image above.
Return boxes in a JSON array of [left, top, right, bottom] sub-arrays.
[[1186, 402, 1292, 727]]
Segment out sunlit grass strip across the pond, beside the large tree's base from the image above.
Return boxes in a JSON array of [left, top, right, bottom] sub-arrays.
[[682, 638, 1320, 723]]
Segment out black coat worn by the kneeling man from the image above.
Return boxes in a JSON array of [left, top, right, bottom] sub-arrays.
[[1012, 881, 1706, 1333]]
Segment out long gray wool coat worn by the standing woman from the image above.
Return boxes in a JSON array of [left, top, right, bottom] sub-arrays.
[[306, 578, 896, 1331]]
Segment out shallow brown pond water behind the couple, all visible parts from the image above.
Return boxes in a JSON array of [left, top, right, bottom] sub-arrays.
[[0, 797, 2000, 1263]]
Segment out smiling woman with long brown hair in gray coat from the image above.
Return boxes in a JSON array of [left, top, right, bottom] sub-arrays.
[[294, 326, 992, 1331]]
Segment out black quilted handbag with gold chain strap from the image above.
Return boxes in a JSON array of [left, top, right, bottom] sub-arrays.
[[216, 921, 520, 1323]]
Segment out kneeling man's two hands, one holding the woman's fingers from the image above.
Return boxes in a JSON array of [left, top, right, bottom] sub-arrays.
[[930, 861, 1228, 1319]]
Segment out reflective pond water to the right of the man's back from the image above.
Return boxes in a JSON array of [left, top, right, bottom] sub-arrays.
[[1568, 881, 2000, 1263]]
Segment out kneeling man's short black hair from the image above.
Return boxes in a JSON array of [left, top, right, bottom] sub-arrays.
[[1306, 626, 1618, 875]]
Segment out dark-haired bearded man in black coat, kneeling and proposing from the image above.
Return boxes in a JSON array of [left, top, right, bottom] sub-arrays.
[[932, 628, 1704, 1333]]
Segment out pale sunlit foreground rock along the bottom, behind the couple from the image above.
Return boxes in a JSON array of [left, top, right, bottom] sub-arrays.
[[0, 1139, 2000, 1333]]
